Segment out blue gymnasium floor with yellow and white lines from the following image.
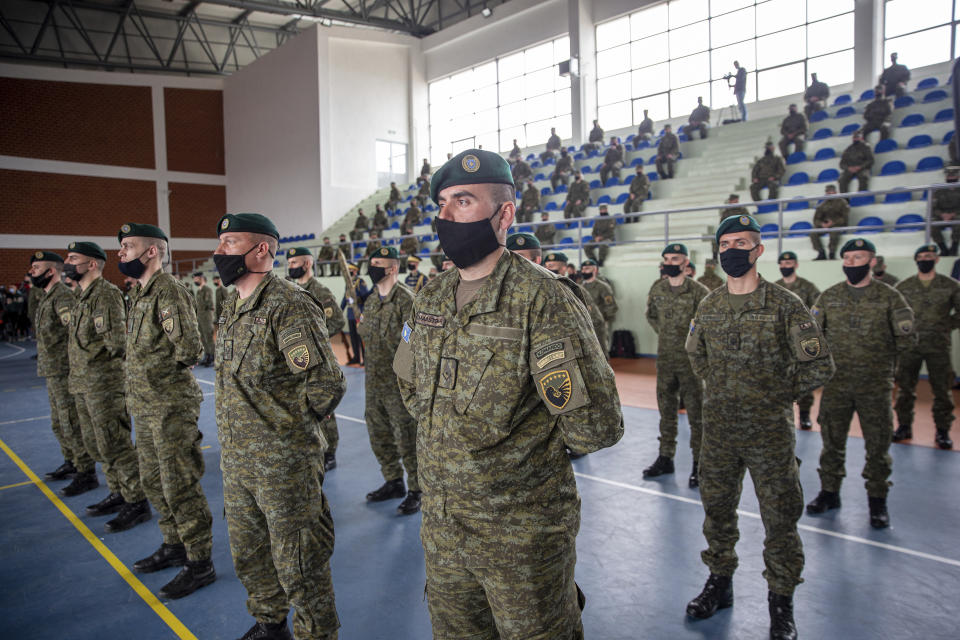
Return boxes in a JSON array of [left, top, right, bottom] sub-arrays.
[[0, 342, 960, 640]]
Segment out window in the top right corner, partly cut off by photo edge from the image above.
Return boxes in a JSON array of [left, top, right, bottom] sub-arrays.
[[883, 0, 960, 69]]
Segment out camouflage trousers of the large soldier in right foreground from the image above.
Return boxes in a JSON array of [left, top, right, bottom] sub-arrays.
[[700, 424, 803, 596]]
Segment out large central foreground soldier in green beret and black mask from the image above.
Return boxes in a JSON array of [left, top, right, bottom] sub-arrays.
[[394, 149, 623, 640]]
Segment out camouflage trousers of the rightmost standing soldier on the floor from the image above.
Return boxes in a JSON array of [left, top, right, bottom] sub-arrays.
[[894, 347, 953, 432]]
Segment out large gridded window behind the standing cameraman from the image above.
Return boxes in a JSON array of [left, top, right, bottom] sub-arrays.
[[596, 0, 856, 129]]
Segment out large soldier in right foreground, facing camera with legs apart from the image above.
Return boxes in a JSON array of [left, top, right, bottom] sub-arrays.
[[686, 216, 834, 640]]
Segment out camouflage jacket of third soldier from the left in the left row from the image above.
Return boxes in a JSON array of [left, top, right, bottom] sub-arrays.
[[124, 271, 202, 411]]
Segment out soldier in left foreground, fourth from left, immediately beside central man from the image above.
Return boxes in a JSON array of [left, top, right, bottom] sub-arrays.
[[213, 213, 346, 640]]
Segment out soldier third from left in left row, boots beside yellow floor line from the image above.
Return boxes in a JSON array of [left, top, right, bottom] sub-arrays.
[[116, 224, 217, 599]]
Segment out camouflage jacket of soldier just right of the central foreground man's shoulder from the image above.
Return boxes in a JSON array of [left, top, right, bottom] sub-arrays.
[[647, 278, 710, 360]]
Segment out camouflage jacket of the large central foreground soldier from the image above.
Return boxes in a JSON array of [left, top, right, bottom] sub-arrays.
[[394, 251, 623, 566]]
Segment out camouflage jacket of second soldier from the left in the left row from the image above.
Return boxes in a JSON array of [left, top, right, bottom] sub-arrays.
[[67, 277, 127, 393]]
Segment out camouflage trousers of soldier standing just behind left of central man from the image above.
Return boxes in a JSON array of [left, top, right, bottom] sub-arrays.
[[364, 377, 420, 491]]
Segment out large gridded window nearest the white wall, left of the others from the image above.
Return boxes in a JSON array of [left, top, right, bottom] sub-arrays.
[[429, 37, 573, 164]]
